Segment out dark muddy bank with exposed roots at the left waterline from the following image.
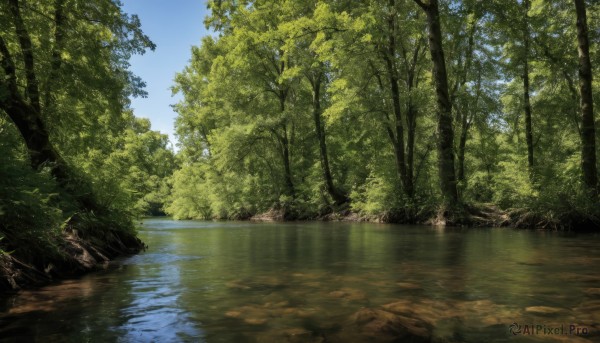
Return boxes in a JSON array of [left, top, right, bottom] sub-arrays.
[[0, 230, 146, 295]]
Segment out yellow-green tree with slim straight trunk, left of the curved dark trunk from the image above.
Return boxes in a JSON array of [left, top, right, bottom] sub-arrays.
[[213, 4, 297, 202]]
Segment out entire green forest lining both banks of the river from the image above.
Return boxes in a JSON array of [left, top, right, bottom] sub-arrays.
[[0, 0, 600, 286]]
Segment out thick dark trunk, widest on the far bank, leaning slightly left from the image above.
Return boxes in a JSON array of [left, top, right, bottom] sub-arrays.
[[414, 0, 459, 207]]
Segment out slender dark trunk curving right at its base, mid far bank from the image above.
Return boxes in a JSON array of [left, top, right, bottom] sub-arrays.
[[310, 73, 349, 206]]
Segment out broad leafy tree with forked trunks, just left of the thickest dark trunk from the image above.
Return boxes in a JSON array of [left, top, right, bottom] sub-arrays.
[[319, 1, 428, 206]]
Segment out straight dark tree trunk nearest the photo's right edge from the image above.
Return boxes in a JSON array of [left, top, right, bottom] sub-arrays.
[[575, 0, 598, 195]]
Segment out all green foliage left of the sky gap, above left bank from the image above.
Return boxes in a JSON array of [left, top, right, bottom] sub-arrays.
[[0, 0, 169, 267]]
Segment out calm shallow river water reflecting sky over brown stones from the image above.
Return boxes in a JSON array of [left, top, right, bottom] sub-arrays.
[[0, 219, 600, 342]]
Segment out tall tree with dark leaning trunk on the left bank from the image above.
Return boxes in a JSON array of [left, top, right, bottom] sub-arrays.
[[0, 0, 154, 207]]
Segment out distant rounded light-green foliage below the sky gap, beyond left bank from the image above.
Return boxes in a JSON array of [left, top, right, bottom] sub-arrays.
[[77, 112, 175, 216]]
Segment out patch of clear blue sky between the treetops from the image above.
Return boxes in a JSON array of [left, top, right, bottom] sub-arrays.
[[122, 0, 208, 144]]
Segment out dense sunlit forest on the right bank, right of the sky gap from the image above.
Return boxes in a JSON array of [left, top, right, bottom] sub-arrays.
[[165, 0, 600, 229]]
